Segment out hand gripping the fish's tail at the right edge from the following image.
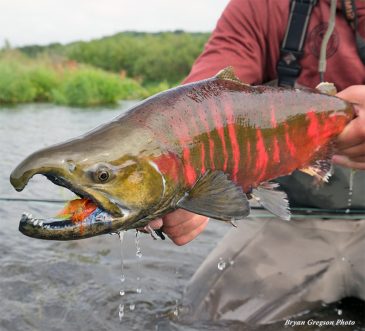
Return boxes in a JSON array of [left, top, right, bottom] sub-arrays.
[[332, 85, 365, 169]]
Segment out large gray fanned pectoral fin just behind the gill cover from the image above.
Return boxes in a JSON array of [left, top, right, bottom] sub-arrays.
[[177, 170, 250, 221]]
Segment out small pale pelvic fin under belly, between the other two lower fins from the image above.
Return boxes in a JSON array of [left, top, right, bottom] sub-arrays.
[[252, 182, 291, 221]]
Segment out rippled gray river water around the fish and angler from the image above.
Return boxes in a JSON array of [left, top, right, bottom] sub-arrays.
[[0, 102, 365, 331]]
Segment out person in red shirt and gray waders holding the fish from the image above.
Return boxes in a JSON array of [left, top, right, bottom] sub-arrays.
[[149, 0, 365, 323]]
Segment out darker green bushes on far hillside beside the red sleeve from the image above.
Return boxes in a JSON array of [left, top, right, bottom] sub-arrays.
[[63, 31, 209, 84]]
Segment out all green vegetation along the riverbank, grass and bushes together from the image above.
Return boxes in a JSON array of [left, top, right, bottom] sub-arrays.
[[0, 31, 208, 106]]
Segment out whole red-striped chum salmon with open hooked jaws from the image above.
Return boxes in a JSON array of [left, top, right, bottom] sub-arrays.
[[10, 67, 354, 240]]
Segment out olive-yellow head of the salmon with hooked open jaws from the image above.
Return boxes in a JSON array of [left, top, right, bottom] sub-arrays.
[[10, 123, 165, 240]]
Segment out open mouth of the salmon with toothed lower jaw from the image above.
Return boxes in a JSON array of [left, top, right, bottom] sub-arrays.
[[19, 174, 143, 240]]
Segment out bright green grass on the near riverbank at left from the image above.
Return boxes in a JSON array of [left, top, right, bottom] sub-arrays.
[[0, 51, 169, 106]]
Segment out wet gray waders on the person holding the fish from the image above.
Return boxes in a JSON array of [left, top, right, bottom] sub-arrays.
[[183, 168, 365, 324]]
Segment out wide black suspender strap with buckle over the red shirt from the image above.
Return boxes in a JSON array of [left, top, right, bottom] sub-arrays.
[[276, 0, 317, 87]]
